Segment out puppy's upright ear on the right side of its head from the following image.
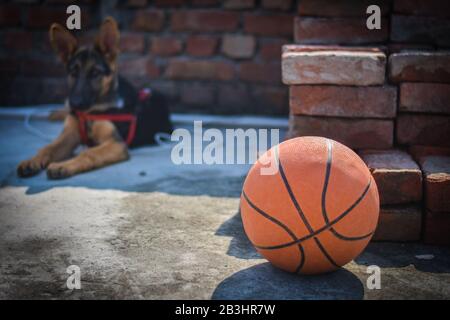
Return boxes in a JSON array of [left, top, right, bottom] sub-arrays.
[[95, 17, 120, 61]]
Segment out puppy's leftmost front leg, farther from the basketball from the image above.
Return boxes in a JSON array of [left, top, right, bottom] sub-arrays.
[[17, 115, 80, 177]]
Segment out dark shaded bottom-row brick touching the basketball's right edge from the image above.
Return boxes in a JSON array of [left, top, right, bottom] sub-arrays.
[[372, 206, 422, 241]]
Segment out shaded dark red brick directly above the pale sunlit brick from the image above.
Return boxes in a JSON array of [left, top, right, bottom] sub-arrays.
[[294, 17, 389, 44]]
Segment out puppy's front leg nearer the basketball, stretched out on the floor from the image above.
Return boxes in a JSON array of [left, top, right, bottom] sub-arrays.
[[47, 121, 129, 179]]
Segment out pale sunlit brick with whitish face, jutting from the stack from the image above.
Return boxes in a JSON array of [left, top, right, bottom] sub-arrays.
[[282, 45, 386, 86]]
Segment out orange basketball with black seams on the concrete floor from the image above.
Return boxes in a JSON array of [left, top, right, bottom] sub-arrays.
[[241, 137, 379, 274]]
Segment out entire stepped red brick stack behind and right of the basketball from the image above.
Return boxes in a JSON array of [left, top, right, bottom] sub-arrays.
[[282, 0, 450, 244]]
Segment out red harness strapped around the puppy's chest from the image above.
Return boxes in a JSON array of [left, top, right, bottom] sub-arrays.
[[75, 88, 151, 145]]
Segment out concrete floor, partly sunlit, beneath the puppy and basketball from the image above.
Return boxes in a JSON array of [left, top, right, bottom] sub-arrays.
[[0, 120, 450, 299]]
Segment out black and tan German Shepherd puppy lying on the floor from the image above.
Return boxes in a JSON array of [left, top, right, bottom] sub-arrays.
[[17, 17, 172, 179]]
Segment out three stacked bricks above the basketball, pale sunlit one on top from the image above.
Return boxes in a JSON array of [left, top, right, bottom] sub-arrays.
[[282, 46, 397, 149]]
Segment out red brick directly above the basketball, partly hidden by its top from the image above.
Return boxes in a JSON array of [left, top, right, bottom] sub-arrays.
[[288, 115, 394, 149]]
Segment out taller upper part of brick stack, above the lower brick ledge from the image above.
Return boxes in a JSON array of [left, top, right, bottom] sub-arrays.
[[282, 0, 450, 149]]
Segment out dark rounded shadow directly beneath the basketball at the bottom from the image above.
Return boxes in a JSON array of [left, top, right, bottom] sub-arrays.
[[211, 263, 364, 300]]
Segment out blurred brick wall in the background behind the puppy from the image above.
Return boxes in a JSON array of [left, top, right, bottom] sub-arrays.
[[0, 0, 297, 114]]
